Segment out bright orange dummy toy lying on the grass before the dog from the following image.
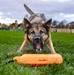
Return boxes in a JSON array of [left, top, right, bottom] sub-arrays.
[[13, 54, 63, 66]]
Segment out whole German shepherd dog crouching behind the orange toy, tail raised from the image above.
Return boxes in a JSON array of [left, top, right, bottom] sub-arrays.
[[18, 4, 56, 54]]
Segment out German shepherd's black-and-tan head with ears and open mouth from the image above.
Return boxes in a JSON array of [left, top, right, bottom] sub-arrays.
[[24, 18, 52, 52]]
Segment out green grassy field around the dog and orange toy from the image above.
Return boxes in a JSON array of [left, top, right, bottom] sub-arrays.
[[0, 31, 74, 75]]
